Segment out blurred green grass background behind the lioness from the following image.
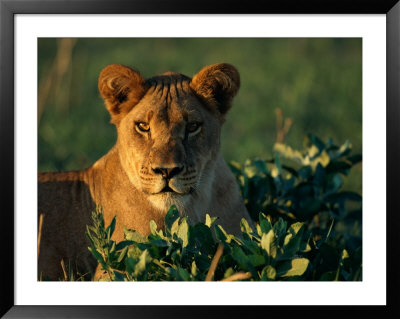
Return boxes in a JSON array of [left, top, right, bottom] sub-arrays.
[[38, 38, 362, 192]]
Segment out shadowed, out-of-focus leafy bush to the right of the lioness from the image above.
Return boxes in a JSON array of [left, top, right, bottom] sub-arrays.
[[231, 135, 361, 221]]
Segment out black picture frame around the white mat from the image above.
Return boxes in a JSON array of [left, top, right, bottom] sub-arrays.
[[0, 0, 400, 318]]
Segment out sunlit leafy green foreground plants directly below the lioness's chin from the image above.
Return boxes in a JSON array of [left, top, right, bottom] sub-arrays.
[[88, 207, 311, 281]]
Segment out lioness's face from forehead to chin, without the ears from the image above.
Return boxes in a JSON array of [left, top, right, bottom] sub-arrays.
[[118, 74, 221, 211]]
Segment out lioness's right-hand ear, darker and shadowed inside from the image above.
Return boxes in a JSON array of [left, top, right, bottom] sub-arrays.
[[190, 63, 240, 118]]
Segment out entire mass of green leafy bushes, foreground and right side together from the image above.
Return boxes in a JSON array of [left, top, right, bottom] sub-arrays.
[[87, 135, 362, 281]]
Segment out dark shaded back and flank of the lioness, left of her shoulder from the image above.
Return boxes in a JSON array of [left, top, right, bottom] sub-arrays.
[[38, 172, 96, 280]]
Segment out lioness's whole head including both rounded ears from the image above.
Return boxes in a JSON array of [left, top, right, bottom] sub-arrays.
[[99, 64, 239, 210]]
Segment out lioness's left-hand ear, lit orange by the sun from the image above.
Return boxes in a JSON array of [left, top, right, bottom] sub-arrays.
[[98, 64, 146, 124]]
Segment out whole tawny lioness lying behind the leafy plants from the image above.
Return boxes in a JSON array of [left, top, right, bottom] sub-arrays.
[[38, 63, 250, 280]]
